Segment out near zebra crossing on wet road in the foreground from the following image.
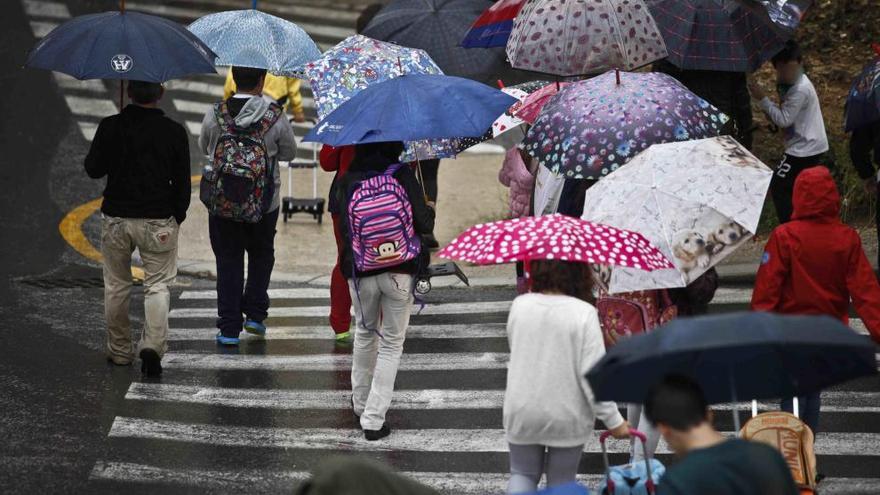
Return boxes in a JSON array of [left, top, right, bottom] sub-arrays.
[[89, 286, 880, 494]]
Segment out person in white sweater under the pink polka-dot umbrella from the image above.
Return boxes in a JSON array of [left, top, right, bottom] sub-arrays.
[[504, 260, 629, 493]]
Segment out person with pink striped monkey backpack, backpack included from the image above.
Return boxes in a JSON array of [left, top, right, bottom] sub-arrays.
[[337, 141, 434, 440]]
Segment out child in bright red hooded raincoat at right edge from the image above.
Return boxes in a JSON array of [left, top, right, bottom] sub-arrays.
[[752, 167, 880, 433]]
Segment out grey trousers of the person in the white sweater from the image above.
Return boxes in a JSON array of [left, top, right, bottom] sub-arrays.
[[507, 443, 584, 493]]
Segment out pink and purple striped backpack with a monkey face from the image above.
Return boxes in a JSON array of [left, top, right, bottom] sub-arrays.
[[348, 163, 421, 272]]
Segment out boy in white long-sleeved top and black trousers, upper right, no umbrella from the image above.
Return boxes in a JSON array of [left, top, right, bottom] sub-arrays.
[[749, 40, 829, 223]]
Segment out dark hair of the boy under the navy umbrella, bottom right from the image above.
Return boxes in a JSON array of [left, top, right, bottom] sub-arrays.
[[645, 375, 709, 431]]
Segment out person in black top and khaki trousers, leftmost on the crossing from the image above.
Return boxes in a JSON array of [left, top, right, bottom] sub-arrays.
[[85, 81, 190, 376]]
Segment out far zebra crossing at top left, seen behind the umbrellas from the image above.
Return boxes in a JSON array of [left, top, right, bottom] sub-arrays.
[[21, 0, 503, 160]]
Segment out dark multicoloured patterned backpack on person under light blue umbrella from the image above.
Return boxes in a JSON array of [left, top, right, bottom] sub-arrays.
[[199, 101, 284, 223]]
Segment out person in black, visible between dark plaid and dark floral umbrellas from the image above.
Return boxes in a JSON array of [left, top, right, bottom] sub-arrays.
[[654, 60, 753, 149]]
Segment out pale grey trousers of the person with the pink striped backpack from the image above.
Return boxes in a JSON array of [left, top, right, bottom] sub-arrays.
[[348, 272, 413, 430]]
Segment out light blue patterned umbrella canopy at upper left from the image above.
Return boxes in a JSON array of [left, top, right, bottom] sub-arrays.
[[189, 10, 321, 76]]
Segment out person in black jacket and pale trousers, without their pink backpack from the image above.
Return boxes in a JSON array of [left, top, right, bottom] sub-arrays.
[[337, 142, 434, 440]]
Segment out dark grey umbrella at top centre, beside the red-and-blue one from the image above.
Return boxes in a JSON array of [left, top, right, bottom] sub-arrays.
[[363, 0, 509, 83]]
